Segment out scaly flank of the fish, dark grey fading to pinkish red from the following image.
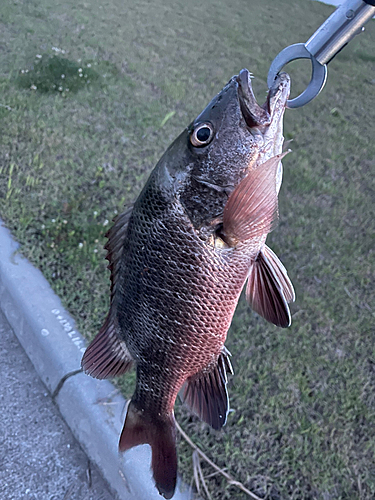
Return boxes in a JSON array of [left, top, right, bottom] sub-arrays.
[[118, 191, 251, 398]]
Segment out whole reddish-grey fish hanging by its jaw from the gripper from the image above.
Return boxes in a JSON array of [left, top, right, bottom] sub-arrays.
[[82, 69, 294, 499]]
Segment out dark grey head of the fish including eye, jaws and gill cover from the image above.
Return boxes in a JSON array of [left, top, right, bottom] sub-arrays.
[[176, 69, 290, 231]]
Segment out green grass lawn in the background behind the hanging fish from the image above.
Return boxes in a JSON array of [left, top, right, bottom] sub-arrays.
[[0, 0, 375, 500]]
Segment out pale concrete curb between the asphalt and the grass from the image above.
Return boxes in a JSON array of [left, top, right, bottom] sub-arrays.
[[0, 219, 190, 500]]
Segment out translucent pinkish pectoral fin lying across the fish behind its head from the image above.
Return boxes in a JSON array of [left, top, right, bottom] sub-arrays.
[[223, 153, 287, 244]]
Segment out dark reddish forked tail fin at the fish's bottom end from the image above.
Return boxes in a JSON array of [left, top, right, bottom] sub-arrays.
[[119, 401, 177, 499]]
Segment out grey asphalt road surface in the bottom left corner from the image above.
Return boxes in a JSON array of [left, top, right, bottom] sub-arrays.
[[0, 310, 115, 500]]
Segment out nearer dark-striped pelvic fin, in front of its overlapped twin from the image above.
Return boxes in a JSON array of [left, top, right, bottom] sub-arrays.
[[246, 247, 291, 328]]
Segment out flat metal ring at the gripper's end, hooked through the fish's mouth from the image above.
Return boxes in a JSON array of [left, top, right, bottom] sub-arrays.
[[267, 43, 327, 108]]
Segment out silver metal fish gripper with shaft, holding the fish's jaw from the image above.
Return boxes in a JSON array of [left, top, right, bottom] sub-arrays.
[[267, 0, 375, 108]]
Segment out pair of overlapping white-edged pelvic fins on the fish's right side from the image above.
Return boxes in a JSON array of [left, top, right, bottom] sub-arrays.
[[246, 247, 294, 328]]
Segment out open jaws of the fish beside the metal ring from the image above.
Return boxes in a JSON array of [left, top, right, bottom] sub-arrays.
[[237, 69, 290, 132]]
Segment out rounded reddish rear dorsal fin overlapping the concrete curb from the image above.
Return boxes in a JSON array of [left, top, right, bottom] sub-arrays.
[[81, 317, 133, 379]]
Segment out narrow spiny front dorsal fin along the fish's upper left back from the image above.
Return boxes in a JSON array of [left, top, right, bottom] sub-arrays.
[[104, 205, 133, 301]]
